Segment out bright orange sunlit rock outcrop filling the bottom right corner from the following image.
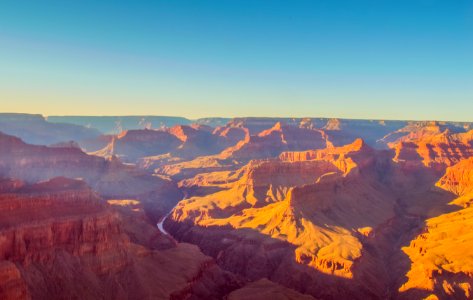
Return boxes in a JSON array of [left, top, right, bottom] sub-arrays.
[[399, 208, 473, 299]]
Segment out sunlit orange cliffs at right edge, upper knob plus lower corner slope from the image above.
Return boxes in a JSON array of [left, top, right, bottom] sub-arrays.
[[394, 158, 473, 299]]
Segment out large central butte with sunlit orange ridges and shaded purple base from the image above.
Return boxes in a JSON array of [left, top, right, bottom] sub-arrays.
[[168, 140, 396, 298]]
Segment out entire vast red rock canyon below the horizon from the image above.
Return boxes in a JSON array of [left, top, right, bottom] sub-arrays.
[[0, 114, 473, 299]]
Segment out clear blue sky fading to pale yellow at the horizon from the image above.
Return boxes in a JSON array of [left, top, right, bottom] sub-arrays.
[[0, 0, 473, 121]]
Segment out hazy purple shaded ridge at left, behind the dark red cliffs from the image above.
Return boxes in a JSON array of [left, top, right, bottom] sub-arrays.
[[0, 133, 181, 219]]
